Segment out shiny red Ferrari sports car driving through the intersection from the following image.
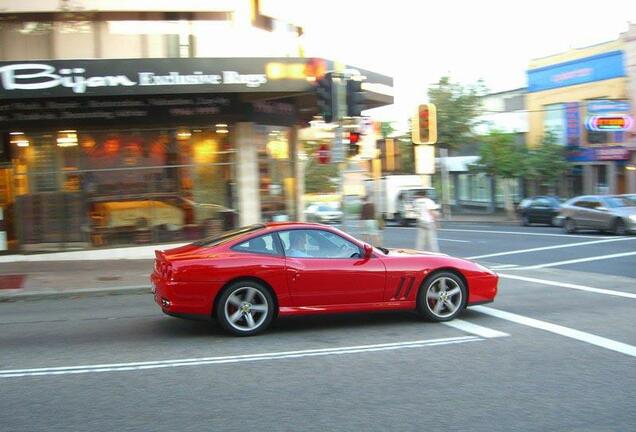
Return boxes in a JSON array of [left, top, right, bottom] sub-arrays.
[[151, 223, 498, 336]]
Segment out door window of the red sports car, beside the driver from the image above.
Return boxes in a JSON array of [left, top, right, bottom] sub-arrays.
[[279, 230, 362, 258]]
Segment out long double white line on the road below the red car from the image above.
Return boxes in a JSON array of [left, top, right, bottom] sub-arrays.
[[0, 336, 485, 378]]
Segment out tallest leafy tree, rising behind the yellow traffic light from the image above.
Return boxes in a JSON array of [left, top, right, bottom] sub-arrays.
[[428, 76, 486, 150]]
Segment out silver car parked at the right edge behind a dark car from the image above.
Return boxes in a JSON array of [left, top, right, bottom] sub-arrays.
[[559, 195, 636, 235]]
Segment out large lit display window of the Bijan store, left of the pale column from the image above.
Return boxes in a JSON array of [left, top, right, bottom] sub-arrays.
[[12, 126, 236, 250]]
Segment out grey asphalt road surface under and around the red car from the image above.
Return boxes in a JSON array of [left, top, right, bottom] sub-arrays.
[[0, 224, 636, 432]]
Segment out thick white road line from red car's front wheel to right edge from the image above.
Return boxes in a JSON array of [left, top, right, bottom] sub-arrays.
[[471, 306, 636, 357]]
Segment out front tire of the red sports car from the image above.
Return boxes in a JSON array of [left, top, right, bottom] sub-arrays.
[[417, 271, 468, 322]]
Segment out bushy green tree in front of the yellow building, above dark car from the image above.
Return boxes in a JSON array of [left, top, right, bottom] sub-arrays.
[[525, 130, 570, 194]]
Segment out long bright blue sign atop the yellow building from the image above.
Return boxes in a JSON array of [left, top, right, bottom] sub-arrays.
[[527, 51, 625, 93]]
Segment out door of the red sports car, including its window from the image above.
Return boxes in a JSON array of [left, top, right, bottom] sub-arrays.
[[279, 229, 386, 306]]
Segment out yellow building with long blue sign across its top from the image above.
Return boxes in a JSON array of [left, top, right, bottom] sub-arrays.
[[526, 39, 632, 195]]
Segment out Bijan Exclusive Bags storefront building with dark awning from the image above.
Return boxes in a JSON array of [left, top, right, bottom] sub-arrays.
[[0, 3, 392, 251]]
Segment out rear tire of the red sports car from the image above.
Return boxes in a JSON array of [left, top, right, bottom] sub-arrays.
[[215, 281, 275, 336]]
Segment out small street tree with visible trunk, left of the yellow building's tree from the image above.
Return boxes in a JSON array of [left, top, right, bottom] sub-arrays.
[[471, 131, 526, 219]]
